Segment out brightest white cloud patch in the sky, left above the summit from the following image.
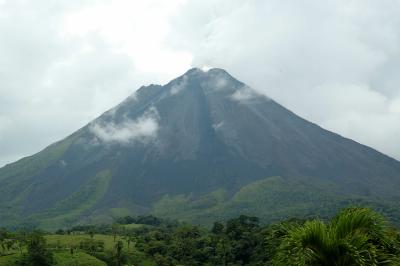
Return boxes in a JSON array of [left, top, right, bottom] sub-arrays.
[[64, 0, 192, 75]]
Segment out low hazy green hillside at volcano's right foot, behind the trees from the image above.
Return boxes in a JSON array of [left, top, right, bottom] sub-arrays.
[[153, 177, 400, 228]]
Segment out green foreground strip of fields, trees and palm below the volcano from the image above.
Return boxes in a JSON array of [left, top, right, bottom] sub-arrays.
[[0, 208, 400, 266]]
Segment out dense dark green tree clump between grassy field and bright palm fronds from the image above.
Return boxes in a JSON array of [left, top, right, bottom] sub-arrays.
[[136, 215, 266, 265]]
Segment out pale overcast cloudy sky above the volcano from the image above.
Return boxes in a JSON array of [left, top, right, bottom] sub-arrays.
[[0, 0, 400, 166]]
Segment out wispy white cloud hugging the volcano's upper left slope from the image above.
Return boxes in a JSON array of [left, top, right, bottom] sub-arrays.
[[90, 108, 159, 144]]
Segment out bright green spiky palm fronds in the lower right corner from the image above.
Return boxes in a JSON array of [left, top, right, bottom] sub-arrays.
[[275, 208, 399, 266]]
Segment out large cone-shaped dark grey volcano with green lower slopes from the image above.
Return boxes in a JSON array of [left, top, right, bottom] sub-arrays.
[[0, 69, 400, 227]]
